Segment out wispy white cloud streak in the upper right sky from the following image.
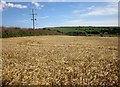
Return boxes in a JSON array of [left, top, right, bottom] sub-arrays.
[[73, 2, 118, 17]]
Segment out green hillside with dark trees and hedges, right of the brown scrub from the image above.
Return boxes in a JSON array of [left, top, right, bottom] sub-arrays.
[[50, 26, 118, 36]]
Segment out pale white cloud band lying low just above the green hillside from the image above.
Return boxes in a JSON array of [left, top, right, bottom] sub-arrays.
[[62, 19, 118, 26]]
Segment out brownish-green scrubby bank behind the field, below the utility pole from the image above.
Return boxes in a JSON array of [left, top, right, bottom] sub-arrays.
[[2, 27, 62, 38]]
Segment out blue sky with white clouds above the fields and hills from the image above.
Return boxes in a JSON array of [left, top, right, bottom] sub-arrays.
[[0, 0, 118, 28]]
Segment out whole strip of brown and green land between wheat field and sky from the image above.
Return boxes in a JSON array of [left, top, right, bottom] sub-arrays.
[[0, 26, 119, 38]]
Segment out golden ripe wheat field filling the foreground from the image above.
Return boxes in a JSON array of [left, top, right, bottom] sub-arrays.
[[2, 36, 118, 85]]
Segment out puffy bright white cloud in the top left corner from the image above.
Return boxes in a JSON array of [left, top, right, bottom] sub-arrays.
[[0, 1, 27, 11]]
